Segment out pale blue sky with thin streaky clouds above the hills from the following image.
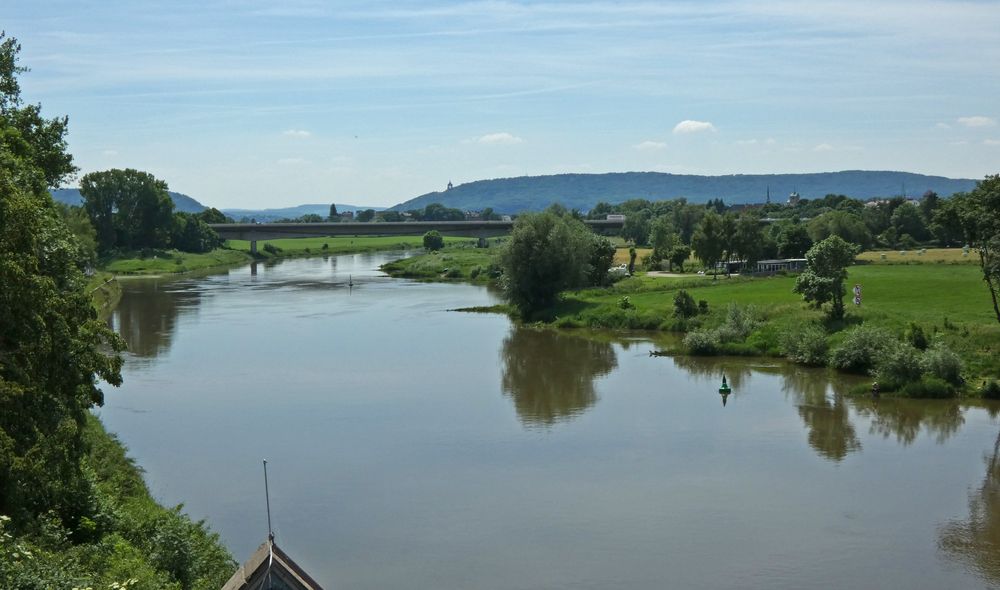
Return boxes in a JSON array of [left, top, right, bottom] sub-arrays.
[[7, 0, 1000, 208]]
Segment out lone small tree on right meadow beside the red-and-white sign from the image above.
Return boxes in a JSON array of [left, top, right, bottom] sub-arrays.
[[793, 236, 858, 319]]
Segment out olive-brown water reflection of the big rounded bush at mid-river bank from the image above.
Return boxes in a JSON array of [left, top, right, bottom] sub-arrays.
[[500, 327, 618, 426]]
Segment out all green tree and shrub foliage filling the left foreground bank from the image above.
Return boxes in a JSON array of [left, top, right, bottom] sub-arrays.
[[0, 34, 233, 590]]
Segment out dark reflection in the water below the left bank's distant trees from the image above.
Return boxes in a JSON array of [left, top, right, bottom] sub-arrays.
[[108, 279, 201, 359]]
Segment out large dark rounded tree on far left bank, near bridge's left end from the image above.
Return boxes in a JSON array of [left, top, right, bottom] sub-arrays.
[[80, 168, 174, 253]]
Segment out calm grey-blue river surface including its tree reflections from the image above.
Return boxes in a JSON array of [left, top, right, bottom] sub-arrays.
[[100, 255, 1000, 590]]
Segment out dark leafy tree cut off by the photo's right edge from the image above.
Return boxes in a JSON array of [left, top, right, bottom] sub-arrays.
[[952, 174, 1000, 322]]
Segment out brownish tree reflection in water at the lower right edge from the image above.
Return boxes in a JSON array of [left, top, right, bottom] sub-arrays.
[[938, 434, 1000, 583]]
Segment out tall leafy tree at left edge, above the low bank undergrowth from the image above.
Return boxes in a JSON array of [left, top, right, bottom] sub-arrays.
[[0, 35, 123, 530]]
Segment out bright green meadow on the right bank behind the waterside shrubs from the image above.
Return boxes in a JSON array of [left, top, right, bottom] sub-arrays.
[[547, 263, 1000, 384]]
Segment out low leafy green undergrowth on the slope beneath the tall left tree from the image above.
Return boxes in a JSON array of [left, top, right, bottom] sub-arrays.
[[0, 416, 236, 590]]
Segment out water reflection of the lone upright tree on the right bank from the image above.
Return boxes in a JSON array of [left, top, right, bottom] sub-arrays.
[[781, 368, 861, 461]]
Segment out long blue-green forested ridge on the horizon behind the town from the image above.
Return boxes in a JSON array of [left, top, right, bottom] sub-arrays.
[[391, 170, 976, 213]]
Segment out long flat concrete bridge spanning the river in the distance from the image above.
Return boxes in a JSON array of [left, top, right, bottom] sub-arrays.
[[210, 219, 624, 253]]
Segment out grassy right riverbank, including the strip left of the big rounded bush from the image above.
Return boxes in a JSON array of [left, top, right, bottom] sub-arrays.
[[384, 248, 1000, 396]]
